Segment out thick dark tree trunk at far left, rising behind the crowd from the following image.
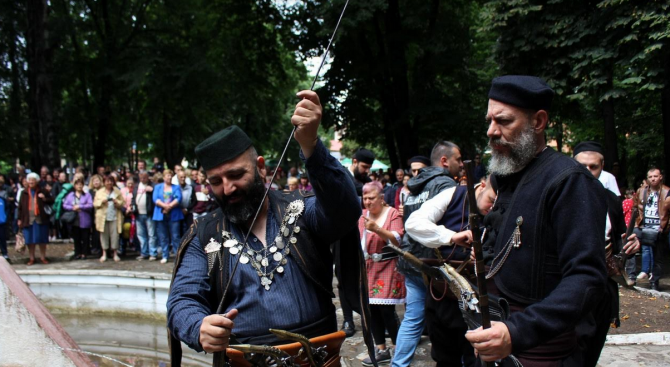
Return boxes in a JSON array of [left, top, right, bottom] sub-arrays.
[[26, 0, 60, 168]]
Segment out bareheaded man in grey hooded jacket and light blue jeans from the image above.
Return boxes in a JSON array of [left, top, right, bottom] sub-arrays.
[[392, 140, 463, 367]]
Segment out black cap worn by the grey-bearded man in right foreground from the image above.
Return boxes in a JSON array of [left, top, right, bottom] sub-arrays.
[[489, 75, 554, 111]]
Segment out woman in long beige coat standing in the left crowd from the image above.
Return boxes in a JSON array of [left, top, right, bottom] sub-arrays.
[[93, 175, 125, 262]]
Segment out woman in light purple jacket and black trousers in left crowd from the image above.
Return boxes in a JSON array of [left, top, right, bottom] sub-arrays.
[[63, 179, 93, 260]]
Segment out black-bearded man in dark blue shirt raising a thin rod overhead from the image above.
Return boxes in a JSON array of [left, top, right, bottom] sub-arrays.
[[167, 91, 365, 365]]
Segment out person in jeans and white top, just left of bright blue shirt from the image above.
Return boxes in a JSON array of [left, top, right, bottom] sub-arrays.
[[131, 171, 158, 261]]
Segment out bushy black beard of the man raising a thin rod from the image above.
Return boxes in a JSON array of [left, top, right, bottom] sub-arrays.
[[214, 171, 265, 224]]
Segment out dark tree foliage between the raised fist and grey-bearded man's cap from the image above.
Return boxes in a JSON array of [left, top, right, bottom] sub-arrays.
[[292, 0, 486, 168]]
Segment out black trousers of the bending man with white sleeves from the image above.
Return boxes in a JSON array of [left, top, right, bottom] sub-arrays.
[[425, 292, 475, 367]]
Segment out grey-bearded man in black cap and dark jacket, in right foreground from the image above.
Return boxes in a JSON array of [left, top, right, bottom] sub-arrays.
[[466, 75, 607, 366]]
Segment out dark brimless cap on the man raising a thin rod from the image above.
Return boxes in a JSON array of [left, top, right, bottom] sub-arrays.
[[195, 125, 251, 170]]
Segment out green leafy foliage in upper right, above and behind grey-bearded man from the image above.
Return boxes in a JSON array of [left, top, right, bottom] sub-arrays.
[[482, 0, 670, 184]]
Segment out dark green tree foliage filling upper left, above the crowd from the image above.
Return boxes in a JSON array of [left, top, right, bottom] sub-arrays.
[[0, 0, 306, 171]]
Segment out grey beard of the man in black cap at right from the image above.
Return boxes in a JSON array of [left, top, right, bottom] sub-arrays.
[[489, 123, 537, 176]]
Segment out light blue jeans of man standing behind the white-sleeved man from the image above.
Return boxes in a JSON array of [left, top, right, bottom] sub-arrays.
[[393, 275, 427, 367]]
